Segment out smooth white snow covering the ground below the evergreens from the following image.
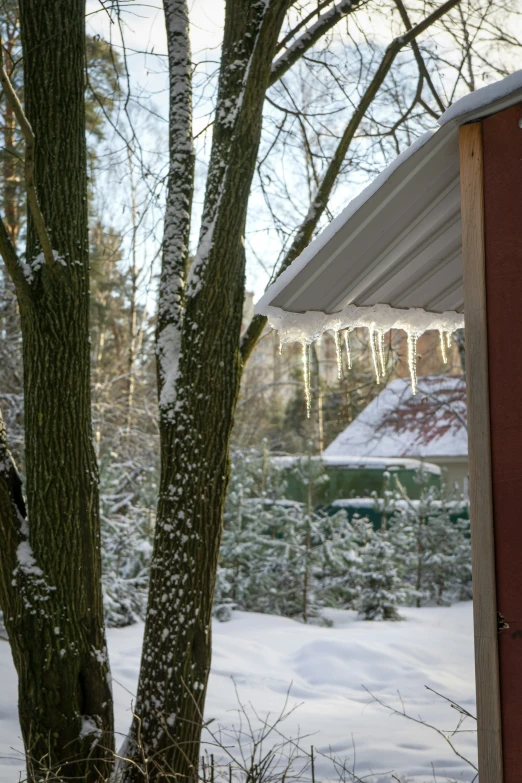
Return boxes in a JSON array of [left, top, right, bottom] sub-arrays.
[[0, 603, 476, 783]]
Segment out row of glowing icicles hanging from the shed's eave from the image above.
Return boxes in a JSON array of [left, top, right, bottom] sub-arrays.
[[279, 327, 451, 418]]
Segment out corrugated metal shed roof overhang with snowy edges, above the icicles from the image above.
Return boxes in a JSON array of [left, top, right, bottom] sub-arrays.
[[256, 71, 522, 342]]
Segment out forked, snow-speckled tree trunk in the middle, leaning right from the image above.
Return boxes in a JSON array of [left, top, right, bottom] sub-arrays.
[[122, 0, 288, 783]]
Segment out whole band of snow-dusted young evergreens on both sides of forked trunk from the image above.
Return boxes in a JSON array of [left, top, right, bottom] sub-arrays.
[[95, 448, 471, 626]]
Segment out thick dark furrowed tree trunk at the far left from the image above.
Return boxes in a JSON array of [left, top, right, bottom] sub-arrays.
[[0, 0, 113, 783]]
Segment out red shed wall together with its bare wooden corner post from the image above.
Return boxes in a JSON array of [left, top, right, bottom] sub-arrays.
[[460, 103, 522, 783]]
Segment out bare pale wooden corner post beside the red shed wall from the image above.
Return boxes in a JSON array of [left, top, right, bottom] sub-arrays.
[[459, 122, 503, 783]]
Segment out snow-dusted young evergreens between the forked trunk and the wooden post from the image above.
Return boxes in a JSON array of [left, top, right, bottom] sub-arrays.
[[215, 450, 471, 622]]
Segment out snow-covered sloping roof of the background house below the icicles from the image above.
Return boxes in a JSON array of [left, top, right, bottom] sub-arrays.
[[324, 375, 468, 459]]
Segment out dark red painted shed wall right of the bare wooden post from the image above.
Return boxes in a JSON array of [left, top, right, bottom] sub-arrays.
[[483, 104, 522, 783]]
